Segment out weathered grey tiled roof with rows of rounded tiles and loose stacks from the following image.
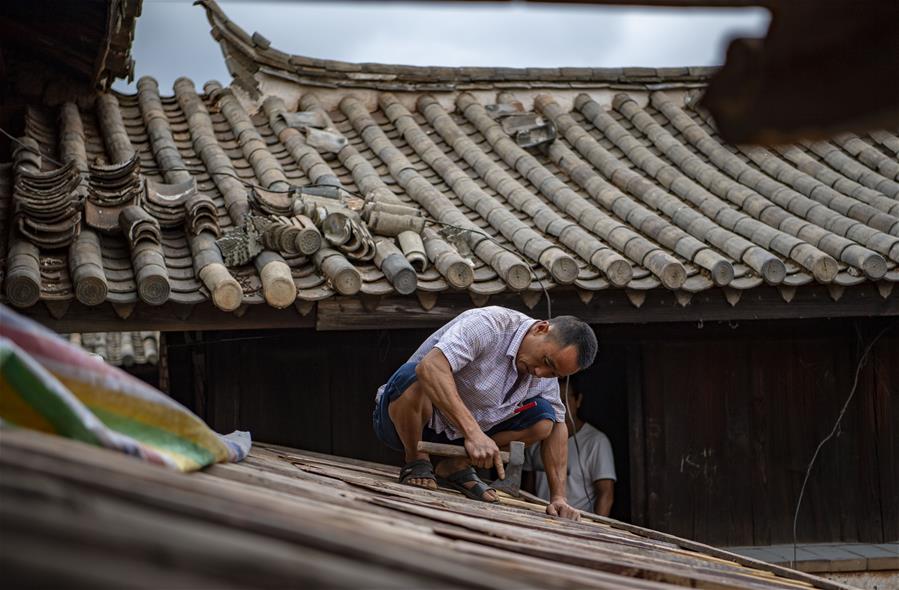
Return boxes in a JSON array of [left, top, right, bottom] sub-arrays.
[[0, 2, 899, 324]]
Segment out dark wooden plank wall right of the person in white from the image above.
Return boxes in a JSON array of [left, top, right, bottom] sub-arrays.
[[624, 320, 899, 545]]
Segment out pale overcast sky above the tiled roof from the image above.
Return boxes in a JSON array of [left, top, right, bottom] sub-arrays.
[[115, 0, 769, 95]]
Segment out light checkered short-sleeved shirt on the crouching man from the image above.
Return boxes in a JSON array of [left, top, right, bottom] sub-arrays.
[[377, 306, 565, 439]]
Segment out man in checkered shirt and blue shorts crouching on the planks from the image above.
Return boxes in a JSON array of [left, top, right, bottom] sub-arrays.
[[372, 307, 597, 520]]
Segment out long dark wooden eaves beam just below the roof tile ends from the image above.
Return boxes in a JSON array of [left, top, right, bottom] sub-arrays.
[[18, 283, 899, 332]]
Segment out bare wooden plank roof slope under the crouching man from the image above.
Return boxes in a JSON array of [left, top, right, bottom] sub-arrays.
[[0, 431, 846, 590]]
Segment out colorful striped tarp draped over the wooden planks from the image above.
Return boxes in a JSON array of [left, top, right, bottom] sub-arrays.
[[0, 305, 250, 471]]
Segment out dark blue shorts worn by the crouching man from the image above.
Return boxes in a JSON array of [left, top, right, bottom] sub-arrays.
[[372, 363, 556, 451]]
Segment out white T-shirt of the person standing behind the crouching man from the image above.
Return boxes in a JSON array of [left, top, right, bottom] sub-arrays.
[[524, 423, 618, 512]]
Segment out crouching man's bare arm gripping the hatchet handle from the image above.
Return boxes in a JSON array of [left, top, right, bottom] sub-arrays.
[[415, 348, 505, 479]]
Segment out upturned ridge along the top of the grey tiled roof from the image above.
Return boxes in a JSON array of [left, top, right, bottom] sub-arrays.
[[194, 0, 718, 97]]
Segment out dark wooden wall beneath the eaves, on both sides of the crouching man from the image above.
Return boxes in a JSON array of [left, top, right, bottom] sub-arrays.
[[167, 320, 899, 545]]
